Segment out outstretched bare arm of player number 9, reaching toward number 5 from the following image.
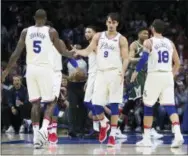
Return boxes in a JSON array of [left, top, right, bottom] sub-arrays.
[[71, 33, 100, 57]]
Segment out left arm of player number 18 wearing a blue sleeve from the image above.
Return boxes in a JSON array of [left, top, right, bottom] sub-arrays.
[[131, 39, 152, 82]]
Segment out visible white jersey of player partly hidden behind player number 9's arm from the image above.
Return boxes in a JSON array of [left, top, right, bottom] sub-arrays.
[[88, 52, 97, 73]]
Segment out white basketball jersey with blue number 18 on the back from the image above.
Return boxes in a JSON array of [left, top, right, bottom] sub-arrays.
[[148, 37, 173, 72]]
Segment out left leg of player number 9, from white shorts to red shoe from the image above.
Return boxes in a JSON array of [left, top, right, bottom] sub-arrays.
[[92, 72, 110, 142]]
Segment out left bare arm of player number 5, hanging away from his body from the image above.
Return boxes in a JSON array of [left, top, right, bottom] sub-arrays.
[[2, 28, 27, 81]]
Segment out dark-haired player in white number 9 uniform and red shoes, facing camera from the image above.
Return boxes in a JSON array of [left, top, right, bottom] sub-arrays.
[[72, 13, 129, 146]]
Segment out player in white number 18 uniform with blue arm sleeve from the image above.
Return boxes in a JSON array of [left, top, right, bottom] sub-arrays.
[[131, 19, 184, 148]]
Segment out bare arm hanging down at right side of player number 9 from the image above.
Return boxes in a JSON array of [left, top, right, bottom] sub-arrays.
[[120, 36, 129, 78]]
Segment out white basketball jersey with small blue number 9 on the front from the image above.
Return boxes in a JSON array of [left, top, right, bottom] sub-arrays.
[[97, 32, 122, 70]]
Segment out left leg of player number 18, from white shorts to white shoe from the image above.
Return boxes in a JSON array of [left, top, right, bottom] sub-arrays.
[[137, 73, 162, 146]]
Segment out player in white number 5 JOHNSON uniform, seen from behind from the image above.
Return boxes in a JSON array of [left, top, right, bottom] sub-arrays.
[[2, 9, 73, 148]]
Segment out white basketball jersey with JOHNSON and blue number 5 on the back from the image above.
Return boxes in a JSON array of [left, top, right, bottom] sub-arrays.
[[25, 26, 53, 68]]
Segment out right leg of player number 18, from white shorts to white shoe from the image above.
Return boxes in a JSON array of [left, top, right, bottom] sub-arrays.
[[160, 74, 184, 148]]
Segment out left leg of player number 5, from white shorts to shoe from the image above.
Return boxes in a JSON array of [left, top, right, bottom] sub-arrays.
[[26, 67, 41, 148]]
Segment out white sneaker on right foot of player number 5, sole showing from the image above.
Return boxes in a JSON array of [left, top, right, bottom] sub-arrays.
[[36, 129, 48, 146]]
